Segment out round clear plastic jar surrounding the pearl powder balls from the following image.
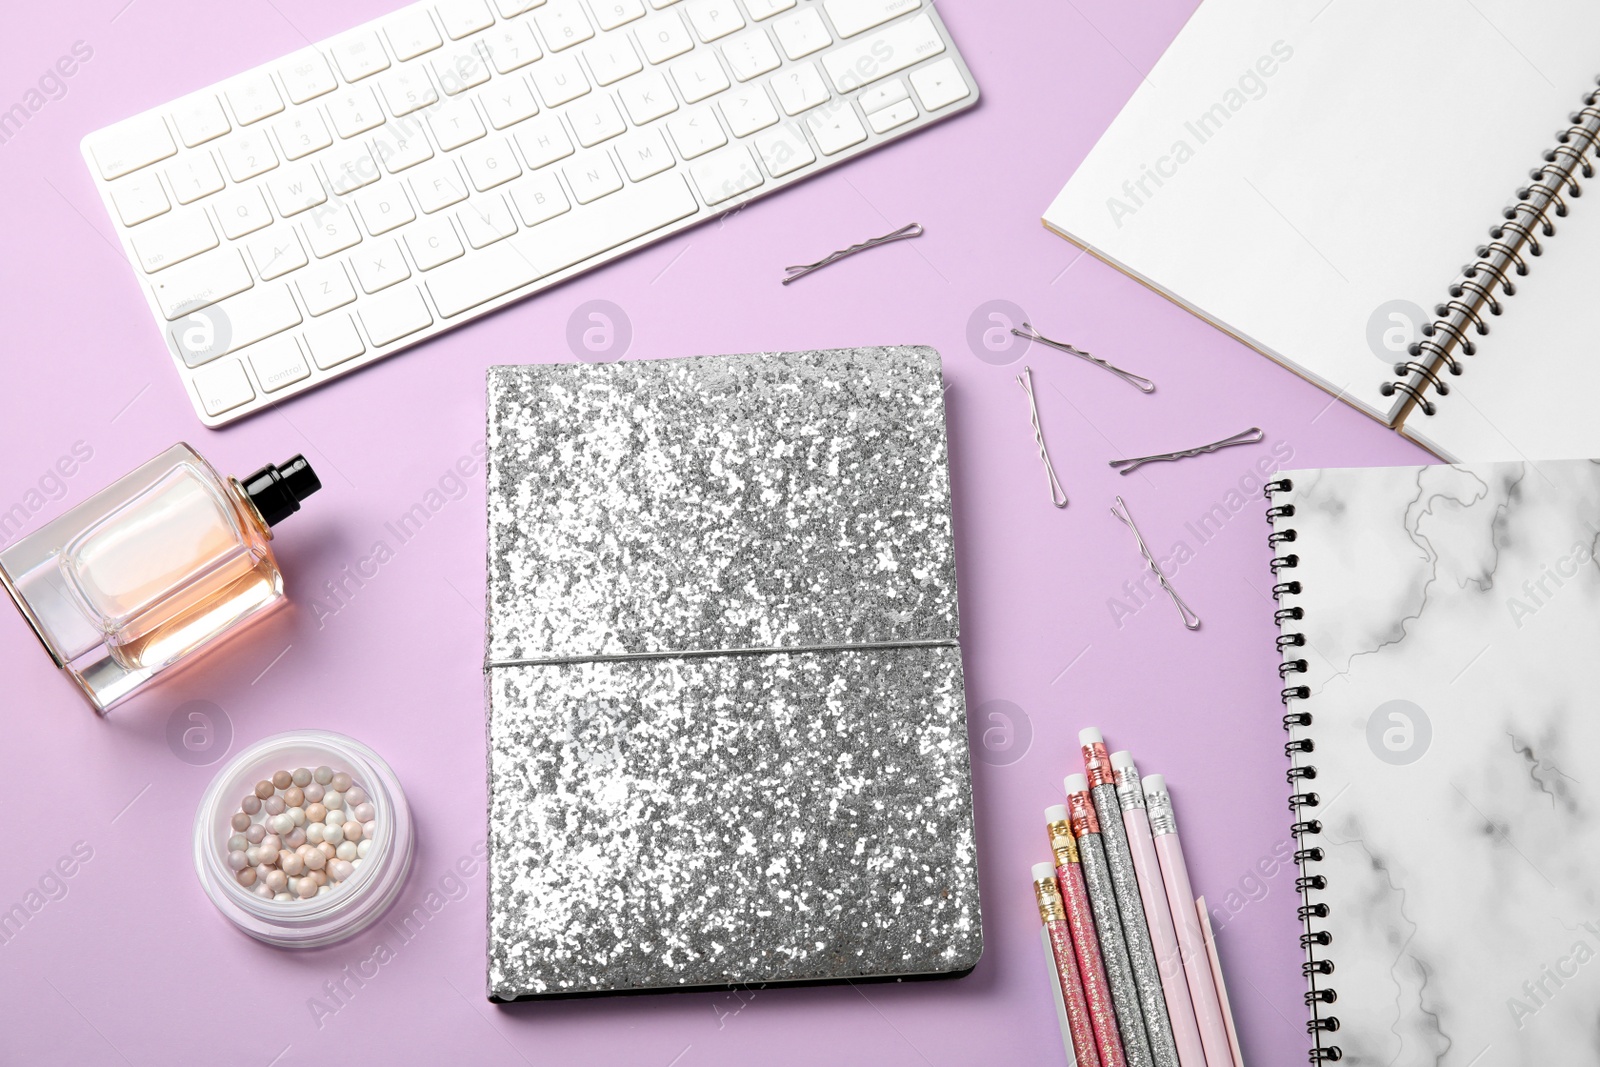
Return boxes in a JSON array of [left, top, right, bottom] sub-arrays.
[[194, 729, 413, 949]]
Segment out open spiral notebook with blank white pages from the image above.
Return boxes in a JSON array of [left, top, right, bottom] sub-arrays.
[[1045, 0, 1600, 461]]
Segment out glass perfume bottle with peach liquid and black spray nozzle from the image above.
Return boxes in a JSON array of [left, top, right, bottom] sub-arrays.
[[0, 445, 322, 713]]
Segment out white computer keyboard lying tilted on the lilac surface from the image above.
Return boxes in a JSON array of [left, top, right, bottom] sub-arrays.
[[83, 0, 978, 426]]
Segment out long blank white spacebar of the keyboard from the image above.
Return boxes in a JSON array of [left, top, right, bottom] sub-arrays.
[[427, 174, 699, 318]]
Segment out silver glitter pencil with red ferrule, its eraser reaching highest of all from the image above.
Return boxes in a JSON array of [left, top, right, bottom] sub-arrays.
[[1078, 726, 1179, 1067]]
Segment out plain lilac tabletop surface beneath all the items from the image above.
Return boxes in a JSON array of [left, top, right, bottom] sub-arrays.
[[0, 0, 1426, 1067]]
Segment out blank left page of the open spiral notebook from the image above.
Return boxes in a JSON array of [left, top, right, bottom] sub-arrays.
[[1045, 0, 1600, 428]]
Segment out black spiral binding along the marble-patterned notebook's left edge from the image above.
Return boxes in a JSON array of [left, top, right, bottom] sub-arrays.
[[1262, 478, 1344, 1064]]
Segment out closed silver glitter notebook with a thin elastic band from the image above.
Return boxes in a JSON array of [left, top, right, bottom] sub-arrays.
[[486, 347, 982, 1001]]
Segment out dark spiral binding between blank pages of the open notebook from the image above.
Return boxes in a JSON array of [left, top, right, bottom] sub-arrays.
[[1378, 78, 1600, 416]]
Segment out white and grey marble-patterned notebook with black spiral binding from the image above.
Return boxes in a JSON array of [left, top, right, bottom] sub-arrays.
[[1269, 461, 1600, 1067]]
